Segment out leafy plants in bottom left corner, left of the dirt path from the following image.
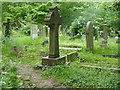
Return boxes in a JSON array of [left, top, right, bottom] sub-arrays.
[[0, 57, 23, 88]]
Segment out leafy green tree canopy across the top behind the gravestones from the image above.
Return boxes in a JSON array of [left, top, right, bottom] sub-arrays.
[[2, 2, 119, 35]]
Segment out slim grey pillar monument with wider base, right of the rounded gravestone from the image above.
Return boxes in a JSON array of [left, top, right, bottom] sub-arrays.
[[100, 24, 108, 48]]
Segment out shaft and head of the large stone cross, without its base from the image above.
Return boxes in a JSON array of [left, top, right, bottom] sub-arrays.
[[45, 6, 60, 58]]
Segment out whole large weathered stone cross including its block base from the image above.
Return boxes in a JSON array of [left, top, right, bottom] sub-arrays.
[[42, 6, 66, 66]]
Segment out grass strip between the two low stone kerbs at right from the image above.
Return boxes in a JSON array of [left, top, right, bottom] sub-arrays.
[[79, 52, 119, 68]]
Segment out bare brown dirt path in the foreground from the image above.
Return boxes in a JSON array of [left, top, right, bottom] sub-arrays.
[[17, 65, 65, 88]]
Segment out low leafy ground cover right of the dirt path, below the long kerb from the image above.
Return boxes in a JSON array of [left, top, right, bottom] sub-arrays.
[[43, 65, 119, 88]]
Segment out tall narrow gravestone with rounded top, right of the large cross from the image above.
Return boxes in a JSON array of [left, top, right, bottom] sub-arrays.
[[86, 21, 93, 51]]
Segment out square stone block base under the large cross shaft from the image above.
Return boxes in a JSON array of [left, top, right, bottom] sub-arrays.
[[42, 56, 66, 66]]
